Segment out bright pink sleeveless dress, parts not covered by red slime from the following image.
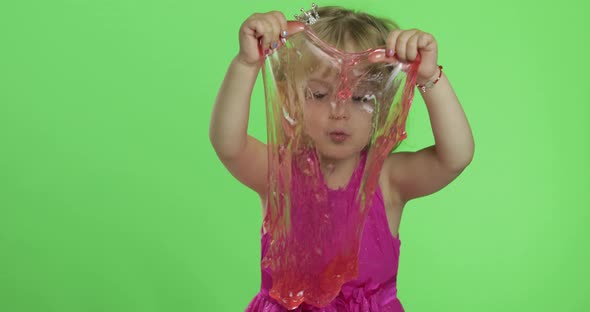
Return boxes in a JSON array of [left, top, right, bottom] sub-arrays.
[[246, 155, 404, 312]]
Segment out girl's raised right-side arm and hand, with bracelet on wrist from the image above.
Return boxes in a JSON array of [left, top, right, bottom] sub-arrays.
[[383, 29, 475, 202]]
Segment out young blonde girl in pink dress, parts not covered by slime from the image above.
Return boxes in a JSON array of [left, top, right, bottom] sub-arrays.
[[210, 3, 474, 312]]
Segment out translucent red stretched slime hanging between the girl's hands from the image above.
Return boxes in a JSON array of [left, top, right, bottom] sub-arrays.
[[261, 22, 419, 310]]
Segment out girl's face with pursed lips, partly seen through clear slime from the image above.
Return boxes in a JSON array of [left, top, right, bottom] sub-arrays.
[[304, 75, 375, 160]]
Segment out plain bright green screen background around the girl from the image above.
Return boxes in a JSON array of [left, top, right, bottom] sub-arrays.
[[0, 0, 590, 312]]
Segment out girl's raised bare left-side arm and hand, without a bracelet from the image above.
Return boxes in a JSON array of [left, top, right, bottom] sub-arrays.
[[209, 12, 287, 196]]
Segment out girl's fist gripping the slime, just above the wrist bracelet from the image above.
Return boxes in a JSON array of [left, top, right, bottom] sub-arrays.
[[385, 29, 439, 84]]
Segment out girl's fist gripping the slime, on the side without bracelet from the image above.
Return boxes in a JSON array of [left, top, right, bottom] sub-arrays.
[[236, 11, 287, 67]]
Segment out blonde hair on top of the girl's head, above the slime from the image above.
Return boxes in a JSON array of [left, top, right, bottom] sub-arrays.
[[310, 6, 399, 50]]
